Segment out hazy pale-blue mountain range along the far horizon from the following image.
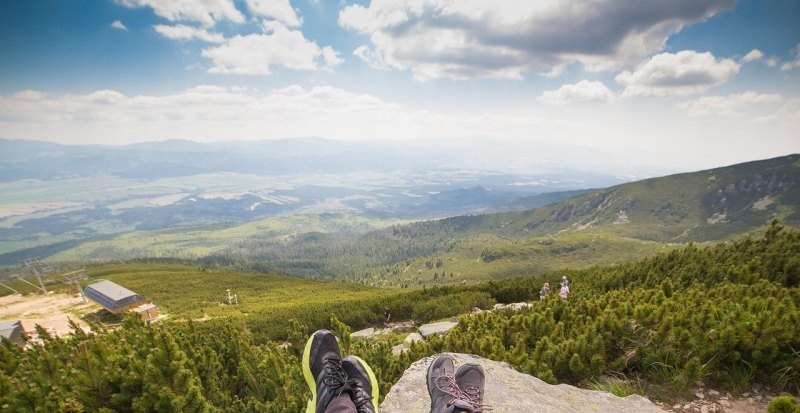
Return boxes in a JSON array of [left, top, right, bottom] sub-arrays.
[[0, 137, 651, 183]]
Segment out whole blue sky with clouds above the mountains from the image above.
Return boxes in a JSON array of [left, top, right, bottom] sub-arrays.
[[0, 0, 800, 169]]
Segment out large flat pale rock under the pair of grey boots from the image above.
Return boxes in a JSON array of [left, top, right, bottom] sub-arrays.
[[379, 354, 665, 413]]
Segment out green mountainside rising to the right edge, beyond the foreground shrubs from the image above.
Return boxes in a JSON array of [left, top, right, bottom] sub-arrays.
[[200, 155, 800, 286]]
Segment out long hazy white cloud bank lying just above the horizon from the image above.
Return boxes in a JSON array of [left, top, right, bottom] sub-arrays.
[[0, 85, 800, 168]]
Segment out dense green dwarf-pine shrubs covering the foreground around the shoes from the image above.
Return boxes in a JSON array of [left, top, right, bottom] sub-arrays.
[[0, 222, 800, 412]]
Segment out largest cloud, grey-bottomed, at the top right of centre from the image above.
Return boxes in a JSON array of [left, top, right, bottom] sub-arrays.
[[339, 0, 734, 80]]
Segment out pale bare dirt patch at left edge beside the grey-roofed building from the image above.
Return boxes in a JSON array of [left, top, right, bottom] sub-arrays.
[[0, 293, 100, 336]]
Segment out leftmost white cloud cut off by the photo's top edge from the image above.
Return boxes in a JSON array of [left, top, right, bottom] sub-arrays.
[[117, 0, 245, 27]]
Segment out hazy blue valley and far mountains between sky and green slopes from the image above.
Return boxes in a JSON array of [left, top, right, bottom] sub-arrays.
[[0, 138, 620, 266]]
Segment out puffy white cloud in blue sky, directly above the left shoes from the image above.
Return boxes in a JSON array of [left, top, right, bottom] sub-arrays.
[[202, 21, 342, 75]]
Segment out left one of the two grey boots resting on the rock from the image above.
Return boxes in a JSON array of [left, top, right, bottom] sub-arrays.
[[427, 354, 472, 413]]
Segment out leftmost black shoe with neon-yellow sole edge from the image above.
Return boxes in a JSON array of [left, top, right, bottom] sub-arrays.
[[303, 330, 347, 413]]
